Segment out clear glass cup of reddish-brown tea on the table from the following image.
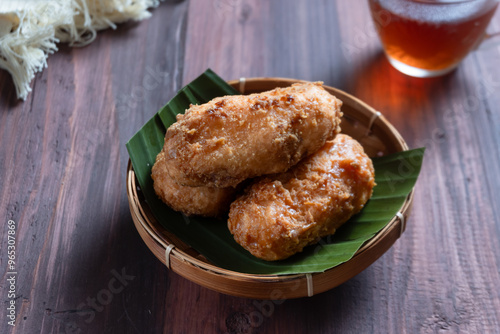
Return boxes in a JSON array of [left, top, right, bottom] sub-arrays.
[[368, 0, 499, 77]]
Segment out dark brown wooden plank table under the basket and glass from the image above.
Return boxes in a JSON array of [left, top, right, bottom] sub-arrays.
[[0, 0, 500, 333]]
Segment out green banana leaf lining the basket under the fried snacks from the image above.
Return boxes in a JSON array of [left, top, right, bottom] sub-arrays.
[[127, 69, 424, 275]]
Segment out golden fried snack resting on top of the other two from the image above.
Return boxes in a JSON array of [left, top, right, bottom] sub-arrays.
[[163, 82, 342, 187]]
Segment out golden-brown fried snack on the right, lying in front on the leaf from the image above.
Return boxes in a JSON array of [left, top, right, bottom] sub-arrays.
[[228, 134, 375, 261]]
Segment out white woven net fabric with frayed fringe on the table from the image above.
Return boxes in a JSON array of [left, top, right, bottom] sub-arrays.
[[0, 0, 159, 100]]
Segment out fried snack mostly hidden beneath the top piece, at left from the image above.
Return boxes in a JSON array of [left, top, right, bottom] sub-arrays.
[[151, 152, 236, 217]]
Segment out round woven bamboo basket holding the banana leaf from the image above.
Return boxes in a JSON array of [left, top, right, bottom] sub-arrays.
[[127, 78, 413, 299]]
